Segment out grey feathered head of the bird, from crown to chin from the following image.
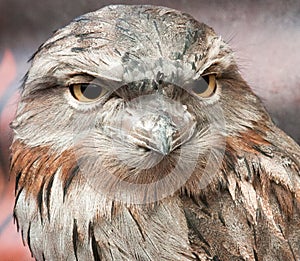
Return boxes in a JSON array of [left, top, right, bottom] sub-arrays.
[[12, 6, 267, 203]]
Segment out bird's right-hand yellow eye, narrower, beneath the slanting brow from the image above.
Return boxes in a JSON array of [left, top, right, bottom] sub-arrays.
[[191, 74, 216, 98]]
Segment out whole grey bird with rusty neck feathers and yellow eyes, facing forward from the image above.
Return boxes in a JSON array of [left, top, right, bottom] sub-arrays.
[[10, 5, 300, 261]]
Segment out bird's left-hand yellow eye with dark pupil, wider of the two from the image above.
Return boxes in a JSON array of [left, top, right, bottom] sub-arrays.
[[69, 83, 107, 102]]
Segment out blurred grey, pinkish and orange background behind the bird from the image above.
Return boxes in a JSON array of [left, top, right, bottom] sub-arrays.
[[0, 0, 300, 260]]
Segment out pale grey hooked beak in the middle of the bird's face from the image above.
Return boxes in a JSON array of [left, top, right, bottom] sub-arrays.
[[131, 110, 196, 156]]
